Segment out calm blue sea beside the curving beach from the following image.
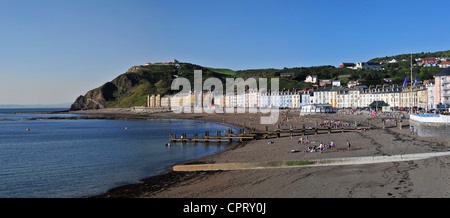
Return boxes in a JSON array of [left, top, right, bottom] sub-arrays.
[[0, 108, 239, 198]]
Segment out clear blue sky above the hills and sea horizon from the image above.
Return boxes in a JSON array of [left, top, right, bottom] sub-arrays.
[[0, 0, 450, 105]]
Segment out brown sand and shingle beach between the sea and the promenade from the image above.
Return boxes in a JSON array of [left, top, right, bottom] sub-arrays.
[[91, 110, 450, 198]]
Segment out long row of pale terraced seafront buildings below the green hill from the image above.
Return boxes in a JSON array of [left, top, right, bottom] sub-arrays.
[[148, 67, 450, 110]]
